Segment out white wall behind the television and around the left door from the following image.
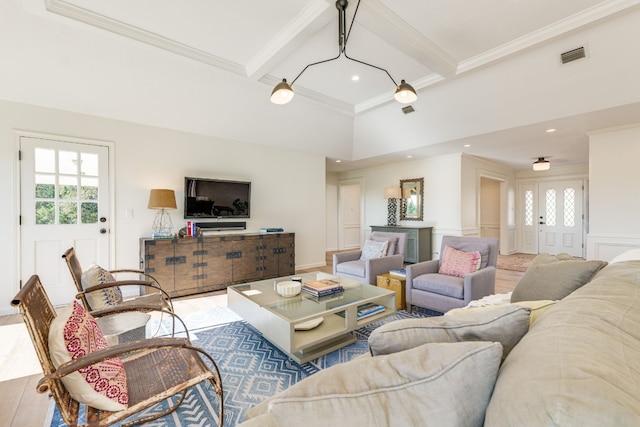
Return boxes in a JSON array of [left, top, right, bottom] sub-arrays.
[[0, 101, 326, 314]]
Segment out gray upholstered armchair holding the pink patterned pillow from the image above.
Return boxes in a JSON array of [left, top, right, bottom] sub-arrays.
[[406, 236, 498, 313]]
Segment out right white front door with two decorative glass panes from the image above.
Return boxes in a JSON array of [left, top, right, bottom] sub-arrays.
[[538, 180, 583, 257]]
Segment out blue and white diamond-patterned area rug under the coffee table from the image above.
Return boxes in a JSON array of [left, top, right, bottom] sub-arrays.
[[50, 308, 440, 427]]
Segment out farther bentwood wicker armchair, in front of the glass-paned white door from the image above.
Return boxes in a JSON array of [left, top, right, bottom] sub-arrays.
[[62, 248, 173, 311]]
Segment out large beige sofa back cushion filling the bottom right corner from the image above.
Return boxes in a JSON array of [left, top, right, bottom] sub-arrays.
[[485, 261, 640, 427]]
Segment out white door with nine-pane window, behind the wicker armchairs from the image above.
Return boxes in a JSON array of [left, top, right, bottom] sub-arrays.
[[20, 136, 110, 305]]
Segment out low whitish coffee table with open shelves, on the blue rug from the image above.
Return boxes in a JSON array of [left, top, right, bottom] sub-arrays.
[[227, 272, 396, 364]]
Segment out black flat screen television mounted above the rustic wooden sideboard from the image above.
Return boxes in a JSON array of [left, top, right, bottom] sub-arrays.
[[184, 177, 251, 219]]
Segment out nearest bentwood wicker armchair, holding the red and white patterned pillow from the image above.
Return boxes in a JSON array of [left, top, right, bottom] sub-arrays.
[[12, 275, 223, 426]]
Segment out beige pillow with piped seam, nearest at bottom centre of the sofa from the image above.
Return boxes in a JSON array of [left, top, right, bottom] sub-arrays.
[[268, 342, 502, 427]]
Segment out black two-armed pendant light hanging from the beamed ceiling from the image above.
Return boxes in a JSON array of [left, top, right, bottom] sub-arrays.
[[271, 0, 418, 105]]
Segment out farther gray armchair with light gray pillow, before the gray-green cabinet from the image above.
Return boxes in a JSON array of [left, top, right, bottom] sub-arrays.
[[333, 231, 407, 285]]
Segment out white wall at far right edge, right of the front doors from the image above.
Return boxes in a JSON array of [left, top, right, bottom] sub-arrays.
[[587, 123, 640, 260]]
